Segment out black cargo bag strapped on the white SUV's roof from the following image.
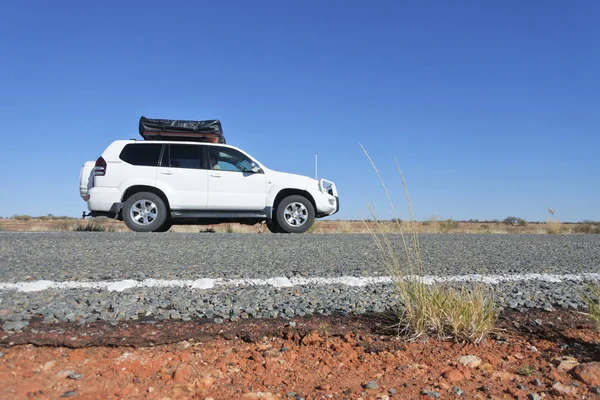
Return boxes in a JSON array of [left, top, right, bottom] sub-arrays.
[[140, 117, 225, 143]]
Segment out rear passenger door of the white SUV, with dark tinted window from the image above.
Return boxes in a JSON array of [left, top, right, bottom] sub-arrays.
[[156, 144, 208, 210]]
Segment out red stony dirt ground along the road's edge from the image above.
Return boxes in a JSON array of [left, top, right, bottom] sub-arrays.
[[0, 311, 600, 400]]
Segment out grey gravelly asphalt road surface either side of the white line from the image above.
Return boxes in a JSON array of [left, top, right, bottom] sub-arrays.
[[0, 232, 600, 330]]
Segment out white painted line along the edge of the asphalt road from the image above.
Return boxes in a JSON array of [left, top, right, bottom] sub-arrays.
[[0, 273, 600, 292]]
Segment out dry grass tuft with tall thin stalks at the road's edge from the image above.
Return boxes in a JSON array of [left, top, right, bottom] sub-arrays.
[[361, 145, 498, 343]]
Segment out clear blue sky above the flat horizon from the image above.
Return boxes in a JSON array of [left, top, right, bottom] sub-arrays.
[[0, 0, 600, 221]]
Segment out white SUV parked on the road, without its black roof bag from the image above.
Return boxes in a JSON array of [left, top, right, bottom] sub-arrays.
[[79, 140, 339, 233]]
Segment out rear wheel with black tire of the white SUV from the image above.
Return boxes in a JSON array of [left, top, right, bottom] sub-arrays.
[[123, 192, 167, 232]]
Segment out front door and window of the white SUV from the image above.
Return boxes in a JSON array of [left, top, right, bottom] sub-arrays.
[[207, 146, 267, 211]]
